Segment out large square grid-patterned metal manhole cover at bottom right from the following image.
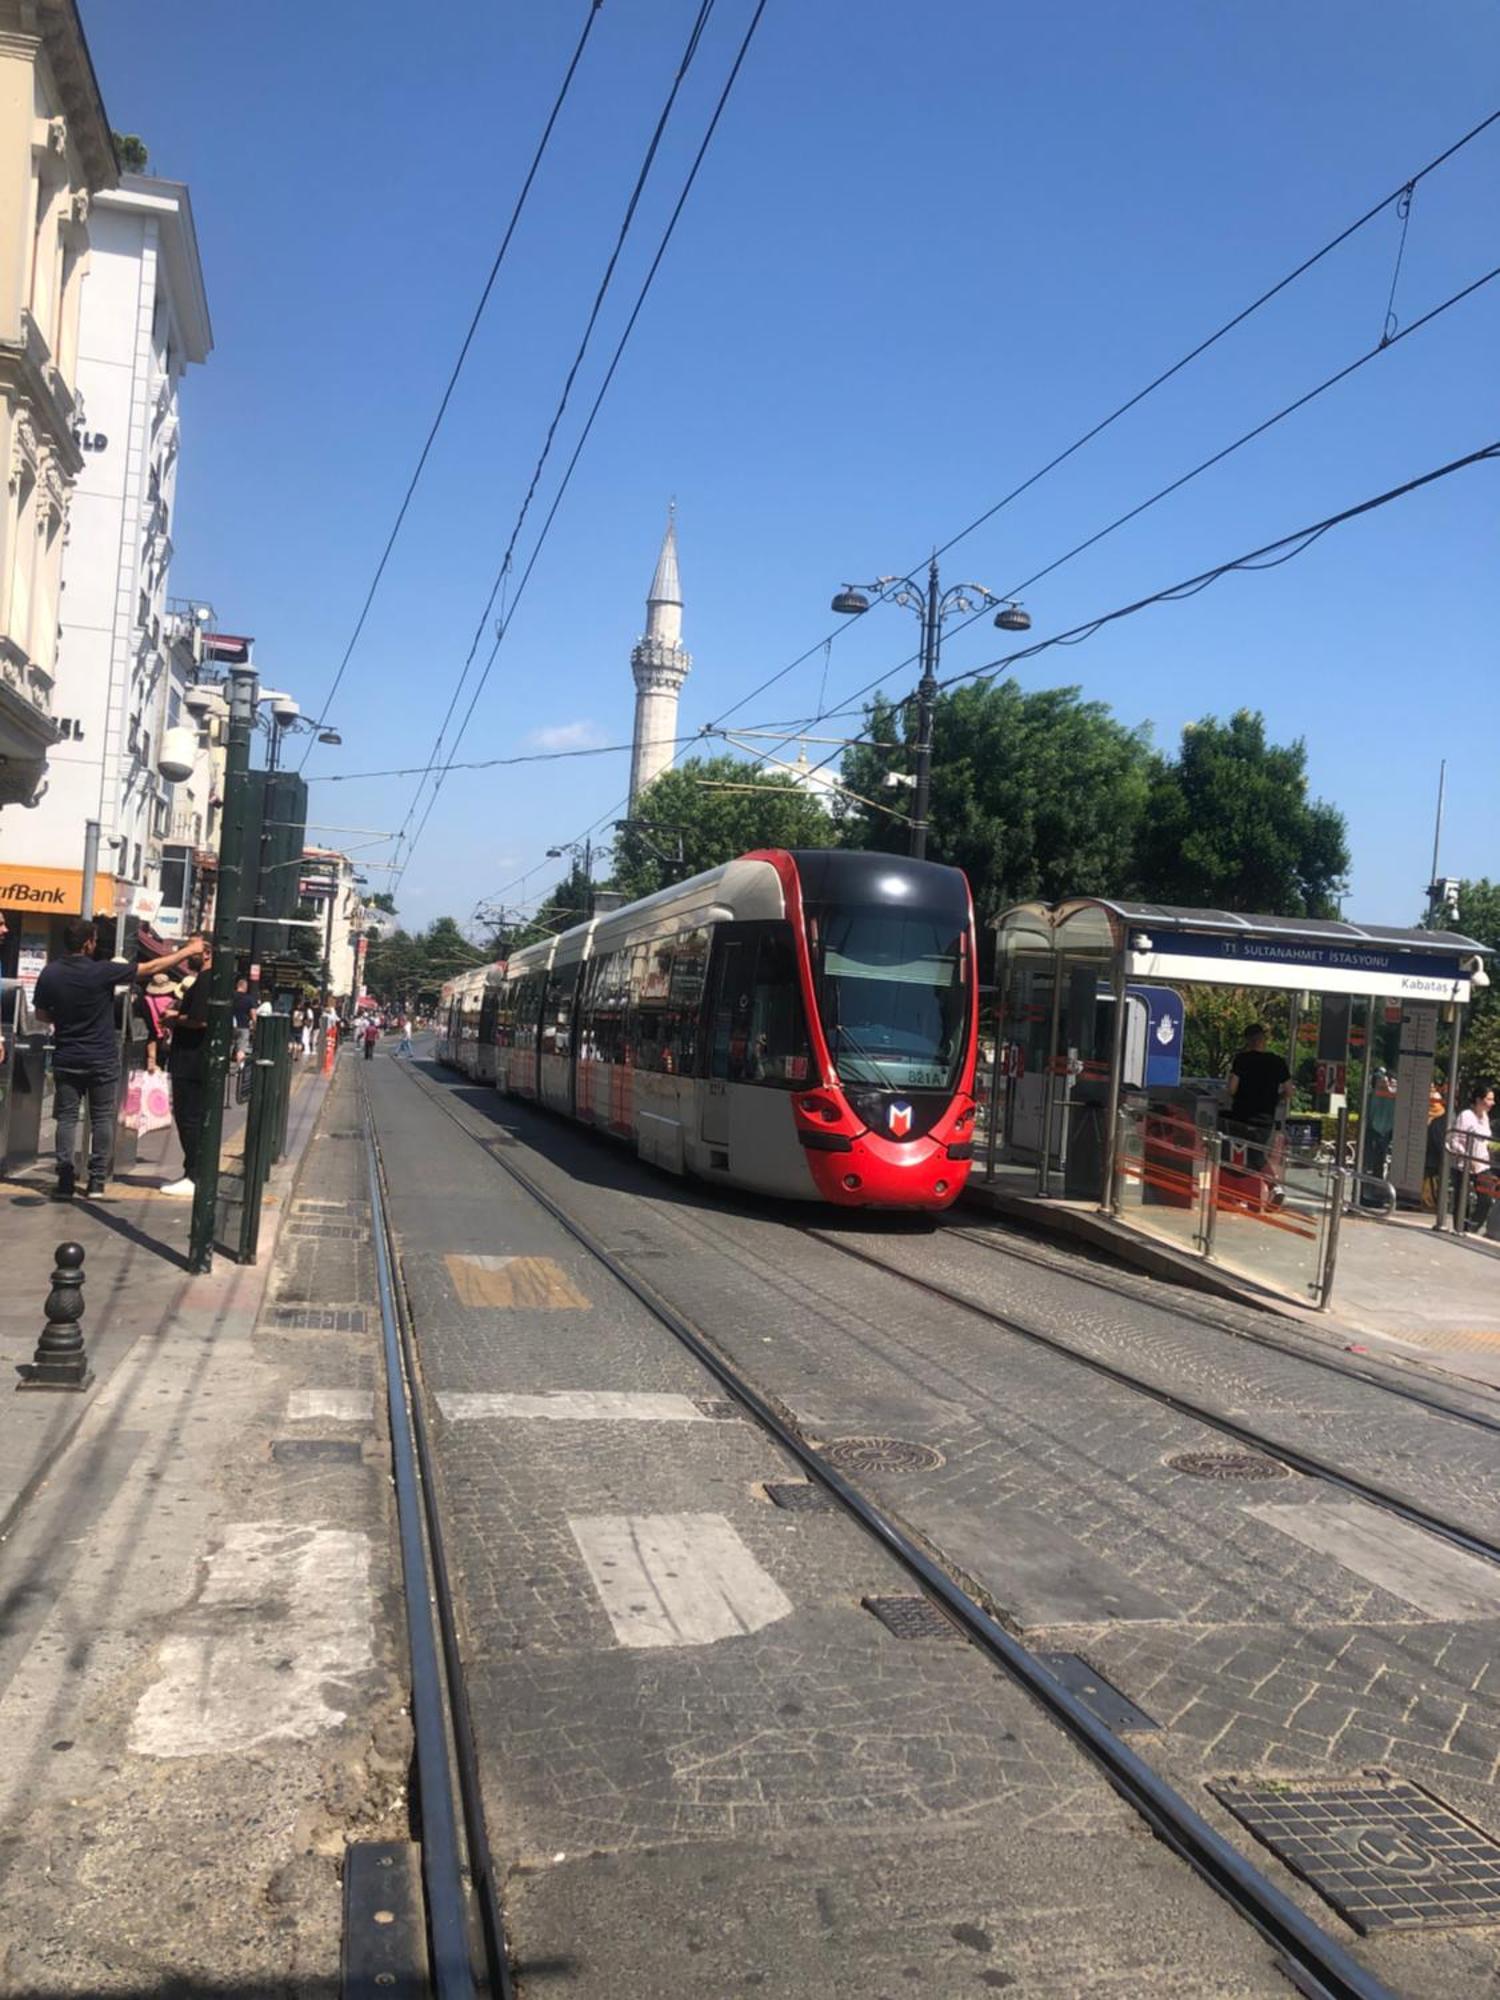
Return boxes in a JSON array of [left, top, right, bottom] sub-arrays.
[[1208, 1772, 1500, 1934]]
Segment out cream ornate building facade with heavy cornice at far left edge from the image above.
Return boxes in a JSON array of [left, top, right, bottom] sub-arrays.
[[0, 0, 118, 820]]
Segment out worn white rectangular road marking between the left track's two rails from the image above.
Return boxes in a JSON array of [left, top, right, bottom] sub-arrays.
[[568, 1514, 792, 1646]]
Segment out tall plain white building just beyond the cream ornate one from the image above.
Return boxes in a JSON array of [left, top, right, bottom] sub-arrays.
[[6, 174, 212, 944]]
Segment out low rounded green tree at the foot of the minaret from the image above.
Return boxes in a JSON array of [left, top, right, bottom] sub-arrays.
[[614, 756, 838, 900]]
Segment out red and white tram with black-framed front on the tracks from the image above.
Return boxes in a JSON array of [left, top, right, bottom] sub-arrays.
[[438, 848, 978, 1208]]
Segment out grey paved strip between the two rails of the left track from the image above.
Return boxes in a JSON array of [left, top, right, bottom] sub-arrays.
[[370, 1064, 1284, 2000]]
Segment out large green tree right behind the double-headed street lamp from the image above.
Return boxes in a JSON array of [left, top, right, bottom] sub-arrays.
[[840, 680, 1152, 922]]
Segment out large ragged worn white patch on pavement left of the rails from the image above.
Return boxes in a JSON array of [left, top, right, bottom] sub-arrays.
[[130, 1522, 374, 1758]]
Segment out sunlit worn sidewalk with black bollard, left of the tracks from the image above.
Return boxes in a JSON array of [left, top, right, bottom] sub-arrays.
[[0, 1066, 410, 2000]]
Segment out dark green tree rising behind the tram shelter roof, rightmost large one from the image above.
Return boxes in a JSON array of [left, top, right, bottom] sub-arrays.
[[1138, 708, 1348, 916]]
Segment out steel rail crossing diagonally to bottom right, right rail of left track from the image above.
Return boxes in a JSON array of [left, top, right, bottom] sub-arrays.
[[390, 1068, 1394, 2000]]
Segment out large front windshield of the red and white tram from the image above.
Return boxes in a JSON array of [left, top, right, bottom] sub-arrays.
[[810, 906, 968, 1090]]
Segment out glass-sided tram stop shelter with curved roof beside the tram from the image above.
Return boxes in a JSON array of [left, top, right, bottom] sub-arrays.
[[976, 896, 1488, 1306]]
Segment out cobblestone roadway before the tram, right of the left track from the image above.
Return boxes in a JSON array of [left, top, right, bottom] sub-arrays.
[[390, 1082, 1500, 1996]]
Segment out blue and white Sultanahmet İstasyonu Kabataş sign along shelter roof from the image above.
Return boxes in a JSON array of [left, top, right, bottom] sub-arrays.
[[1126, 932, 1470, 1002]]
